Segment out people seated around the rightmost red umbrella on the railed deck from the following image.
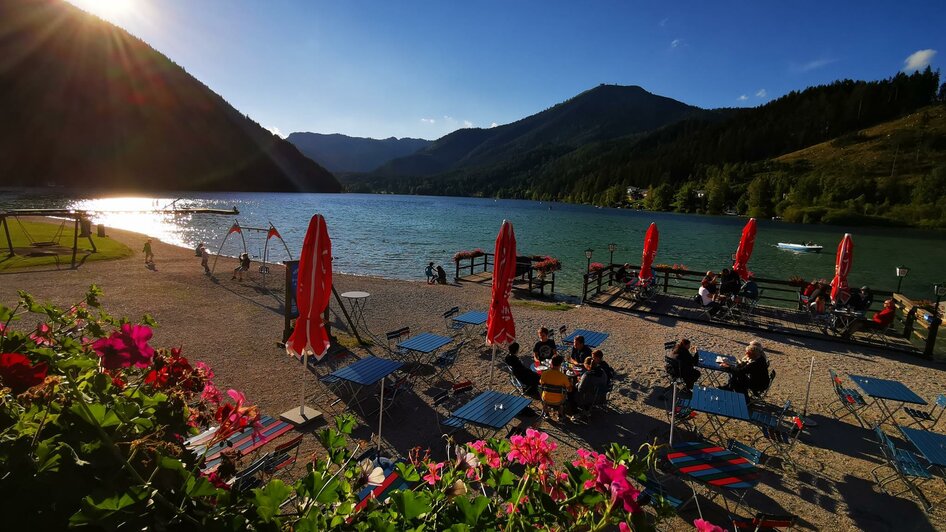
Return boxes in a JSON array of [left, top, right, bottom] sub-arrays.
[[799, 279, 897, 338]]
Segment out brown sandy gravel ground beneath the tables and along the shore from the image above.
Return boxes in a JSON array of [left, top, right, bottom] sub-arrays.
[[0, 230, 946, 531]]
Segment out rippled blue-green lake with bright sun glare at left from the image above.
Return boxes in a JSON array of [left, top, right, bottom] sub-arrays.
[[0, 190, 946, 299]]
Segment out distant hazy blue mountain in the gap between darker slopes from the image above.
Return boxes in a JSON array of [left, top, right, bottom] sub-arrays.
[[286, 133, 431, 173]]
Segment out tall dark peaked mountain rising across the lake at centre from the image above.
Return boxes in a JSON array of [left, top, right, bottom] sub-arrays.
[[373, 85, 703, 177]]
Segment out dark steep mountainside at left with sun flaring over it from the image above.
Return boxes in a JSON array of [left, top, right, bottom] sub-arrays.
[[0, 0, 341, 192]]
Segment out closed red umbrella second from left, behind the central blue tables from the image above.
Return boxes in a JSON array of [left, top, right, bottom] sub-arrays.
[[486, 220, 516, 386]]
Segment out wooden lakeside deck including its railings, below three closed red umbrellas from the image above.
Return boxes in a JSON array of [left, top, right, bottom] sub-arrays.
[[582, 264, 938, 358]]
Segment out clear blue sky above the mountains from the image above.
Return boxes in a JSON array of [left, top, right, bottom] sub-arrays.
[[71, 0, 946, 139]]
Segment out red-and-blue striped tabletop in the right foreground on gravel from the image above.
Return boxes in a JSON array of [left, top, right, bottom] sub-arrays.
[[667, 442, 760, 490]]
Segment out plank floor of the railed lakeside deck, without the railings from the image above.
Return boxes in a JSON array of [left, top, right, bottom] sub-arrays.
[[585, 286, 919, 353]]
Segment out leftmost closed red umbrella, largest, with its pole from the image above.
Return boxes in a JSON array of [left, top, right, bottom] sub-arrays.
[[286, 214, 332, 419]]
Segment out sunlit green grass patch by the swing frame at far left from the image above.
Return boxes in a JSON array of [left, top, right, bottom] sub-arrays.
[[0, 218, 134, 271]]
